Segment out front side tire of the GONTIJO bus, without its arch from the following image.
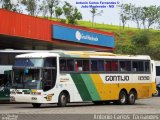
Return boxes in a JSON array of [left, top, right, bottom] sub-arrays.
[[58, 92, 68, 107]]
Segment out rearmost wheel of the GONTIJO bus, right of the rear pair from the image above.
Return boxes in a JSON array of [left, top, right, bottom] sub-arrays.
[[128, 90, 137, 105]]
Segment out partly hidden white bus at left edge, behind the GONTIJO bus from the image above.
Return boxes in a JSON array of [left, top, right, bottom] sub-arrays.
[[0, 49, 49, 100]]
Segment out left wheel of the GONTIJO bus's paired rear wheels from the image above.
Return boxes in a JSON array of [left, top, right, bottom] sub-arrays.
[[117, 90, 127, 105]]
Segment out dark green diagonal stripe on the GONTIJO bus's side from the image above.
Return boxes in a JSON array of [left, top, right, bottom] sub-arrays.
[[71, 74, 92, 101]]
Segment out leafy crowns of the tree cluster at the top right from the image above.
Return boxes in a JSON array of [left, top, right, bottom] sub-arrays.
[[120, 4, 160, 30]]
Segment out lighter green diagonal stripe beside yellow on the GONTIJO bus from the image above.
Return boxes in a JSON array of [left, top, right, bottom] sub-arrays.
[[81, 74, 101, 101]]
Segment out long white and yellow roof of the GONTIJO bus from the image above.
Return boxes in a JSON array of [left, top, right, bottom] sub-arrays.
[[16, 50, 150, 59]]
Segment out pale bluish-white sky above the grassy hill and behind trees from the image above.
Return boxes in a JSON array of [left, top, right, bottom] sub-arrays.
[[7, 0, 160, 28]]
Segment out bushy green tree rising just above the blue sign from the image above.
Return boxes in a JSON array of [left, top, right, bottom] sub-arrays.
[[62, 1, 82, 24]]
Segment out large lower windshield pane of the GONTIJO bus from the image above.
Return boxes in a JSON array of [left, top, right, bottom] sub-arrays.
[[13, 68, 42, 89]]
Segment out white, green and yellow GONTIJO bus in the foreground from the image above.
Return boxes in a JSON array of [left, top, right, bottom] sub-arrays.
[[10, 51, 156, 107]]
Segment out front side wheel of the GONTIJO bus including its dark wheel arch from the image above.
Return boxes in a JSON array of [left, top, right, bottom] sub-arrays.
[[58, 90, 70, 107]]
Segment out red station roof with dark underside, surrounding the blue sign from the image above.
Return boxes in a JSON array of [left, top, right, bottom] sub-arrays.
[[0, 9, 114, 51]]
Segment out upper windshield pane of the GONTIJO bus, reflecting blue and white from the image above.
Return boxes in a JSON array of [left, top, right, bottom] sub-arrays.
[[15, 58, 44, 67]]
